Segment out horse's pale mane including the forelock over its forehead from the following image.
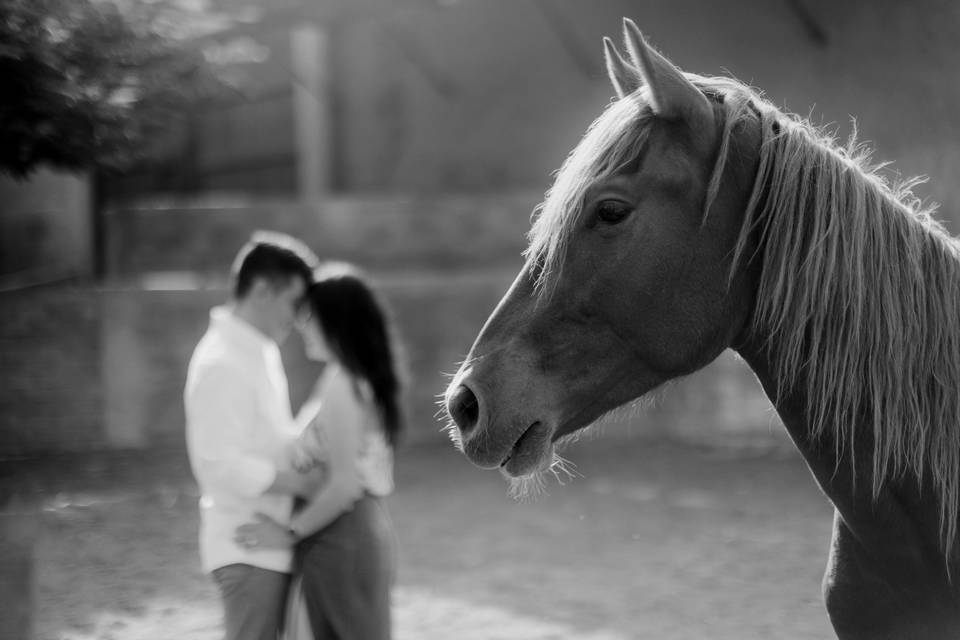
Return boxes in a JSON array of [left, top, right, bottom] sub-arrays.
[[525, 74, 960, 552]]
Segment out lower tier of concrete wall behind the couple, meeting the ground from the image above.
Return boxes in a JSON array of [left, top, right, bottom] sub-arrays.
[[0, 271, 786, 458]]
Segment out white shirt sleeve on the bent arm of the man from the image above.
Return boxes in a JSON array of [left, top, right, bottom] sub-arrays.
[[186, 367, 276, 498]]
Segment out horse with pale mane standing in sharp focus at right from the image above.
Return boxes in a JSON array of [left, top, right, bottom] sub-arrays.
[[443, 19, 960, 640]]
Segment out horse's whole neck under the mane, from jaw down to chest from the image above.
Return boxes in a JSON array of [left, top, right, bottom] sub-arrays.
[[735, 100, 960, 570]]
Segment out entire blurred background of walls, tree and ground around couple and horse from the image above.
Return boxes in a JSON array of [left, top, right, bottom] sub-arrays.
[[0, 0, 960, 639]]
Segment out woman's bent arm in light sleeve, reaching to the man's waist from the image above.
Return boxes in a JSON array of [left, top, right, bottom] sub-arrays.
[[290, 365, 367, 538]]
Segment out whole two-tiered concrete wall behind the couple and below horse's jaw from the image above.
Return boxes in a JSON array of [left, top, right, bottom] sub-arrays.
[[0, 192, 786, 457]]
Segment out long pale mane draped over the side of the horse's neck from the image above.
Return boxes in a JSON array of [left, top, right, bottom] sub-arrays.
[[734, 111, 960, 498]]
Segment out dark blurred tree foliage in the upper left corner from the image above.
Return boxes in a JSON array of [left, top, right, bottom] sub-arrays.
[[0, 0, 232, 177]]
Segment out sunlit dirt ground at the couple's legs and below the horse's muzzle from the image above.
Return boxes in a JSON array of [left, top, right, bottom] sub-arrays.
[[4, 439, 833, 640]]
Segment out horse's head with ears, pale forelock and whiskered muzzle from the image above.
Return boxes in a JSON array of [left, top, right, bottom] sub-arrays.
[[445, 20, 759, 477]]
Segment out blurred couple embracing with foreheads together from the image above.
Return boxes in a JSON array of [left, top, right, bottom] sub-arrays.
[[184, 232, 402, 640]]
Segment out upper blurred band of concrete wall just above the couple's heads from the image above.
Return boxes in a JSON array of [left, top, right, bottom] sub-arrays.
[[106, 191, 541, 278]]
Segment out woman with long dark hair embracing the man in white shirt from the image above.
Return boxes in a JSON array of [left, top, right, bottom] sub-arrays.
[[237, 264, 402, 640]]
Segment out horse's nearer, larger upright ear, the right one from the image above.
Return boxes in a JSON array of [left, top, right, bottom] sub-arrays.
[[623, 18, 713, 122]]
